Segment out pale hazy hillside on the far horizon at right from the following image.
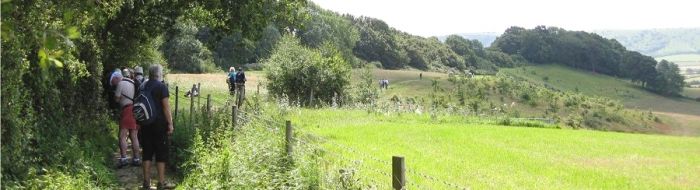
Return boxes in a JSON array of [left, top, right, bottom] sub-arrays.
[[594, 28, 700, 57]]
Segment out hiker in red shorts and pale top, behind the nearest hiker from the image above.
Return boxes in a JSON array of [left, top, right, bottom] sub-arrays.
[[114, 69, 141, 168]]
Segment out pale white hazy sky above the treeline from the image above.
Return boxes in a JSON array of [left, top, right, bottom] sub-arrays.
[[311, 0, 700, 36]]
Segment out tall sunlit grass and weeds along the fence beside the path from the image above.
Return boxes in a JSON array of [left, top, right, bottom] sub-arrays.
[[174, 97, 319, 189]]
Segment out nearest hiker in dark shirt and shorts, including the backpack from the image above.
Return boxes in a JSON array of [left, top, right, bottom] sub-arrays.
[[134, 64, 174, 189]]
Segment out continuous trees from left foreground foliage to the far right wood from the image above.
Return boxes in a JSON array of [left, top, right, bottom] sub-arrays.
[[2, 0, 683, 188]]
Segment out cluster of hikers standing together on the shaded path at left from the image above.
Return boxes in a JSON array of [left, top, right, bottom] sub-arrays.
[[109, 64, 174, 189]]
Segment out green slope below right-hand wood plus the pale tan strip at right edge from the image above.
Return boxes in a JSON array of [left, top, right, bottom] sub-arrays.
[[500, 64, 700, 135]]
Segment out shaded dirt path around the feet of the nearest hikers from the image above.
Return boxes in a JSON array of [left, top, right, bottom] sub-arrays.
[[112, 144, 178, 189]]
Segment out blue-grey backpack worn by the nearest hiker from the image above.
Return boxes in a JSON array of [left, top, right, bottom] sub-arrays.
[[133, 82, 161, 126]]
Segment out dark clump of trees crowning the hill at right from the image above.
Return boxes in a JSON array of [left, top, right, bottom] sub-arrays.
[[492, 26, 684, 95]]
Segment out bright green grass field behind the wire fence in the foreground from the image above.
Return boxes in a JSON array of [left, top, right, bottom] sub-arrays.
[[291, 109, 700, 189]]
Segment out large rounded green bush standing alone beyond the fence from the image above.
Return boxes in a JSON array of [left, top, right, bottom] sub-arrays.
[[263, 36, 350, 106]]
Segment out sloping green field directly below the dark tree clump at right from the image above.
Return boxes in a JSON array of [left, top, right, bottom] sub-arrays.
[[502, 65, 700, 116]]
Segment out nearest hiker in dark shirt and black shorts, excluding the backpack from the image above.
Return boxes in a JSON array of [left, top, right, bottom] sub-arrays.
[[139, 64, 174, 189]]
